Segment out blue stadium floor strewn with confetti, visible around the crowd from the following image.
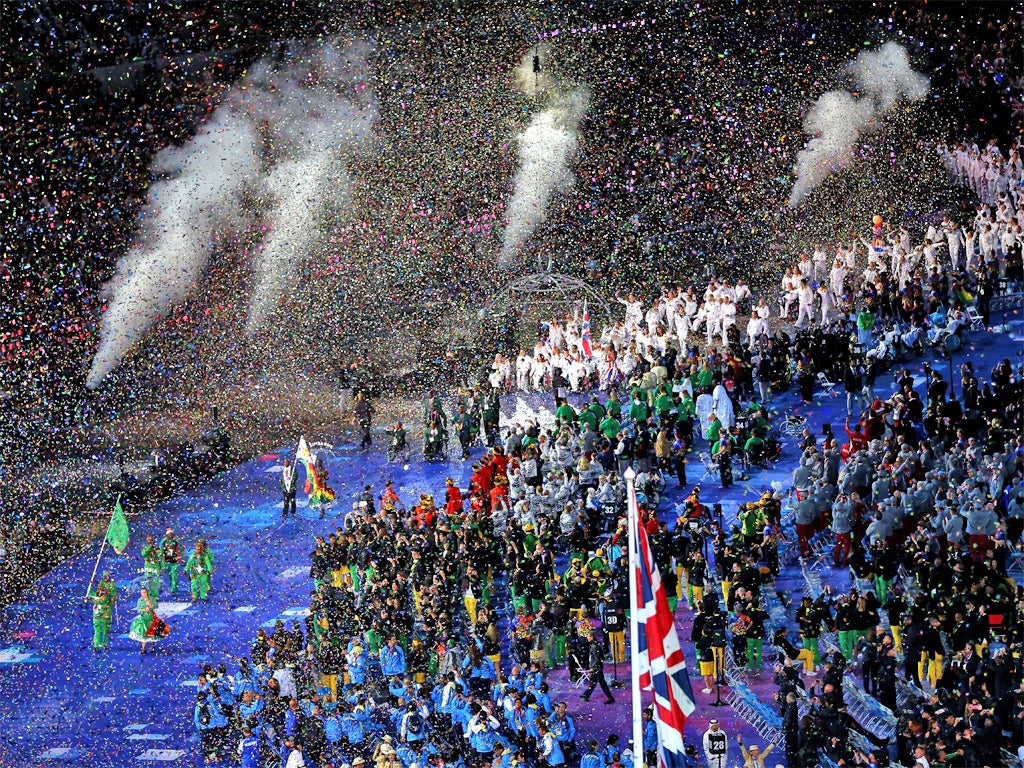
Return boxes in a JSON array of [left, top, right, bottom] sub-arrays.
[[0, 321, 1024, 768]]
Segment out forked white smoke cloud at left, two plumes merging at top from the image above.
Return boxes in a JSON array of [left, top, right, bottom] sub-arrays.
[[86, 43, 376, 389]]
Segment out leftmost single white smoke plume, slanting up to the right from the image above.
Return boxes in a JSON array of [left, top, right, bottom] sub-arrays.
[[86, 108, 259, 389]]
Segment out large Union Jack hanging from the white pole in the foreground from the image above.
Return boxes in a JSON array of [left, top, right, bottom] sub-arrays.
[[629, 485, 694, 768]]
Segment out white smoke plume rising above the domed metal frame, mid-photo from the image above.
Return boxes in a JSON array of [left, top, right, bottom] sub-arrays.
[[501, 88, 590, 266]]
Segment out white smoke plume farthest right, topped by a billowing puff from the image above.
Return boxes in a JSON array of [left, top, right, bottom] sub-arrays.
[[790, 43, 929, 208]]
